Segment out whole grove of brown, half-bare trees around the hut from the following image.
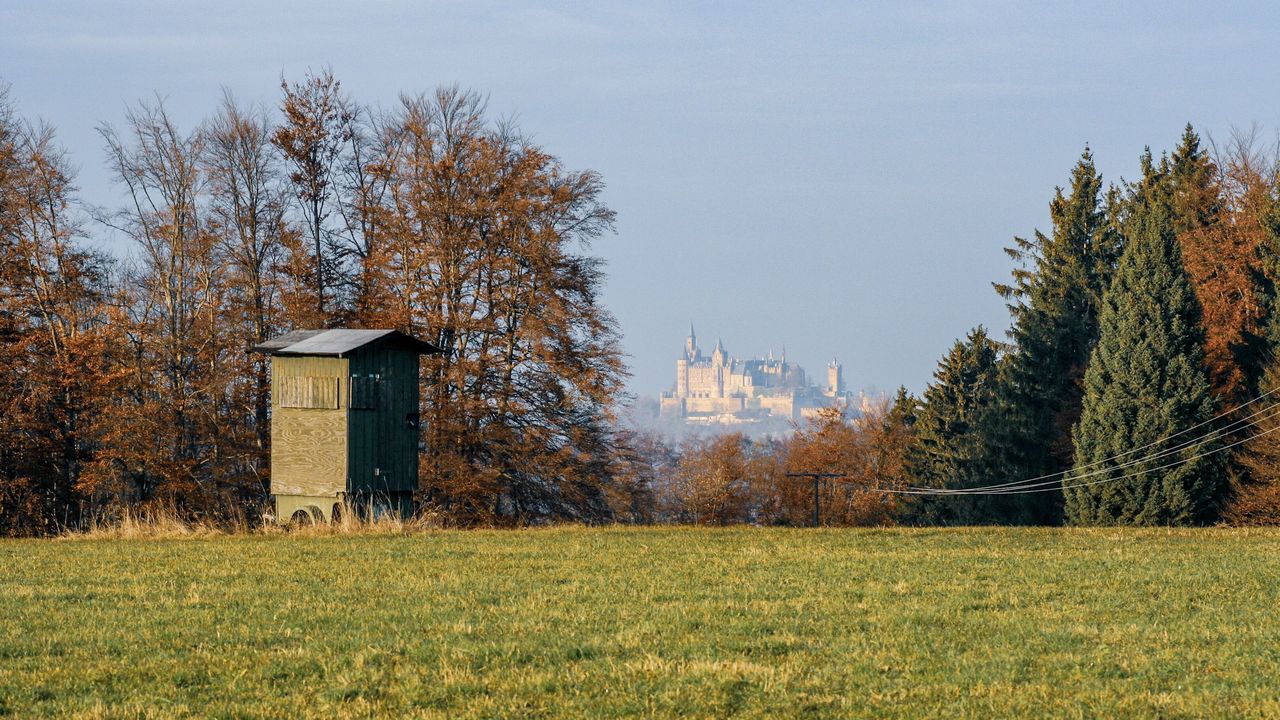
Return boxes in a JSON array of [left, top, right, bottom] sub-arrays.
[[0, 72, 626, 534]]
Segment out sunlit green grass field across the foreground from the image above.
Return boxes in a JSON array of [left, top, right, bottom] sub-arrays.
[[0, 528, 1280, 717]]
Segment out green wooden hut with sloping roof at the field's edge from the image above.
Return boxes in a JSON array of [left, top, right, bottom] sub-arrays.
[[253, 329, 440, 523]]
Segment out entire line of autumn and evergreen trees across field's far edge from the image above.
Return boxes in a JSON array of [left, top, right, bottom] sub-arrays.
[[0, 72, 1280, 534]]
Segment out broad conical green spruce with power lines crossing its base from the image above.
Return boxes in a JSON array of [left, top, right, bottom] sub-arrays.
[[1064, 179, 1226, 525]]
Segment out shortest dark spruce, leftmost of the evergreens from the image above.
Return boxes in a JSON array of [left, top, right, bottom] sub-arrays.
[[905, 327, 1027, 525]]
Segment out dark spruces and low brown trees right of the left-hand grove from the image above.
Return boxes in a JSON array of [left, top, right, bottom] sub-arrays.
[[627, 126, 1280, 525]]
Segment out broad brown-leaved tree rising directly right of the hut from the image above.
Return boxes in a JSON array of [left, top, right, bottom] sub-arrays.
[[358, 87, 625, 520]]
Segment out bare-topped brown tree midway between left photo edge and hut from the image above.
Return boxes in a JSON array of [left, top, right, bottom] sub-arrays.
[[82, 102, 261, 515]]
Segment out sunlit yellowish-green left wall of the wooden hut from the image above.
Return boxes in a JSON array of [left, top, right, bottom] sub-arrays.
[[271, 356, 348, 496]]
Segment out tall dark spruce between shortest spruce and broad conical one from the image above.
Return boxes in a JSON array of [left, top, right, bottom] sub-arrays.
[[996, 147, 1120, 523]]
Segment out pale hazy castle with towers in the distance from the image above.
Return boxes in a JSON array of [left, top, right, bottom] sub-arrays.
[[659, 325, 850, 425]]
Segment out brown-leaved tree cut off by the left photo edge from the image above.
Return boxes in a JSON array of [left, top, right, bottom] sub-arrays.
[[0, 99, 114, 536]]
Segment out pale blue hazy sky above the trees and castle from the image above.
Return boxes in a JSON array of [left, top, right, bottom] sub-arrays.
[[0, 0, 1280, 395]]
